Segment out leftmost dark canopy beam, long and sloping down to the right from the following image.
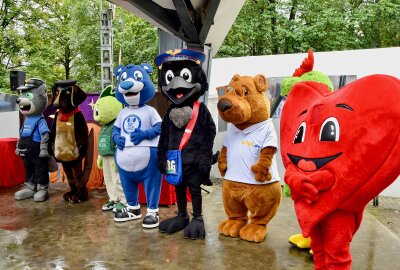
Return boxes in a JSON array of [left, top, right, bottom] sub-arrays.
[[128, 0, 190, 42]]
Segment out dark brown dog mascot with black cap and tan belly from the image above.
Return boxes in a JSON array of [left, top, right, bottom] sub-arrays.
[[50, 80, 88, 203]]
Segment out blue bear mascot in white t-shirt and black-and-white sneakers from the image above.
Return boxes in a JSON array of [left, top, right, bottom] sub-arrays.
[[112, 64, 161, 228]]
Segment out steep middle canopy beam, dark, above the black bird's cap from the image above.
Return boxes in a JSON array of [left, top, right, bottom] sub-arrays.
[[172, 0, 200, 43]]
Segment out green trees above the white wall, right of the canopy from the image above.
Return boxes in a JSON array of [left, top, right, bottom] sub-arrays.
[[217, 0, 400, 57]]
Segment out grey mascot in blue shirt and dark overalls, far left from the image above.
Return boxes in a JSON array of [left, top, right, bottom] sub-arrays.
[[15, 79, 50, 202]]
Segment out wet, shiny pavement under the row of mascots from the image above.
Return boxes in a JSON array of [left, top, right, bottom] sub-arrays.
[[0, 183, 400, 270]]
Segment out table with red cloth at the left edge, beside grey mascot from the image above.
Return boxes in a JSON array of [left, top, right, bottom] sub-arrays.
[[0, 138, 25, 187]]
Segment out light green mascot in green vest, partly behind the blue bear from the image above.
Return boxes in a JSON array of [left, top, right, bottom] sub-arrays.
[[93, 85, 126, 212]]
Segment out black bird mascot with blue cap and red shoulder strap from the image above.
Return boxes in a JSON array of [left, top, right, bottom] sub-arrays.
[[155, 49, 216, 239]]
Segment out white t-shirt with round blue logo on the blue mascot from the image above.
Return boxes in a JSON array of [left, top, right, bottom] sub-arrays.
[[114, 105, 161, 147]]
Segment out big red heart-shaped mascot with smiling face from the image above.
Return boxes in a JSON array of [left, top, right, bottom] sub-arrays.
[[281, 51, 400, 269]]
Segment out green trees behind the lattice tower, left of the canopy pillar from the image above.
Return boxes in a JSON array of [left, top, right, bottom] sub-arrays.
[[0, 0, 158, 92]]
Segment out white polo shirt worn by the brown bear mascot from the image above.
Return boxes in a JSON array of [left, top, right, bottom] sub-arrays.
[[224, 118, 280, 185]]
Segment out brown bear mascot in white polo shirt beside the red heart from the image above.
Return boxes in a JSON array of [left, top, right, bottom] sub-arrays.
[[217, 75, 282, 242]]
